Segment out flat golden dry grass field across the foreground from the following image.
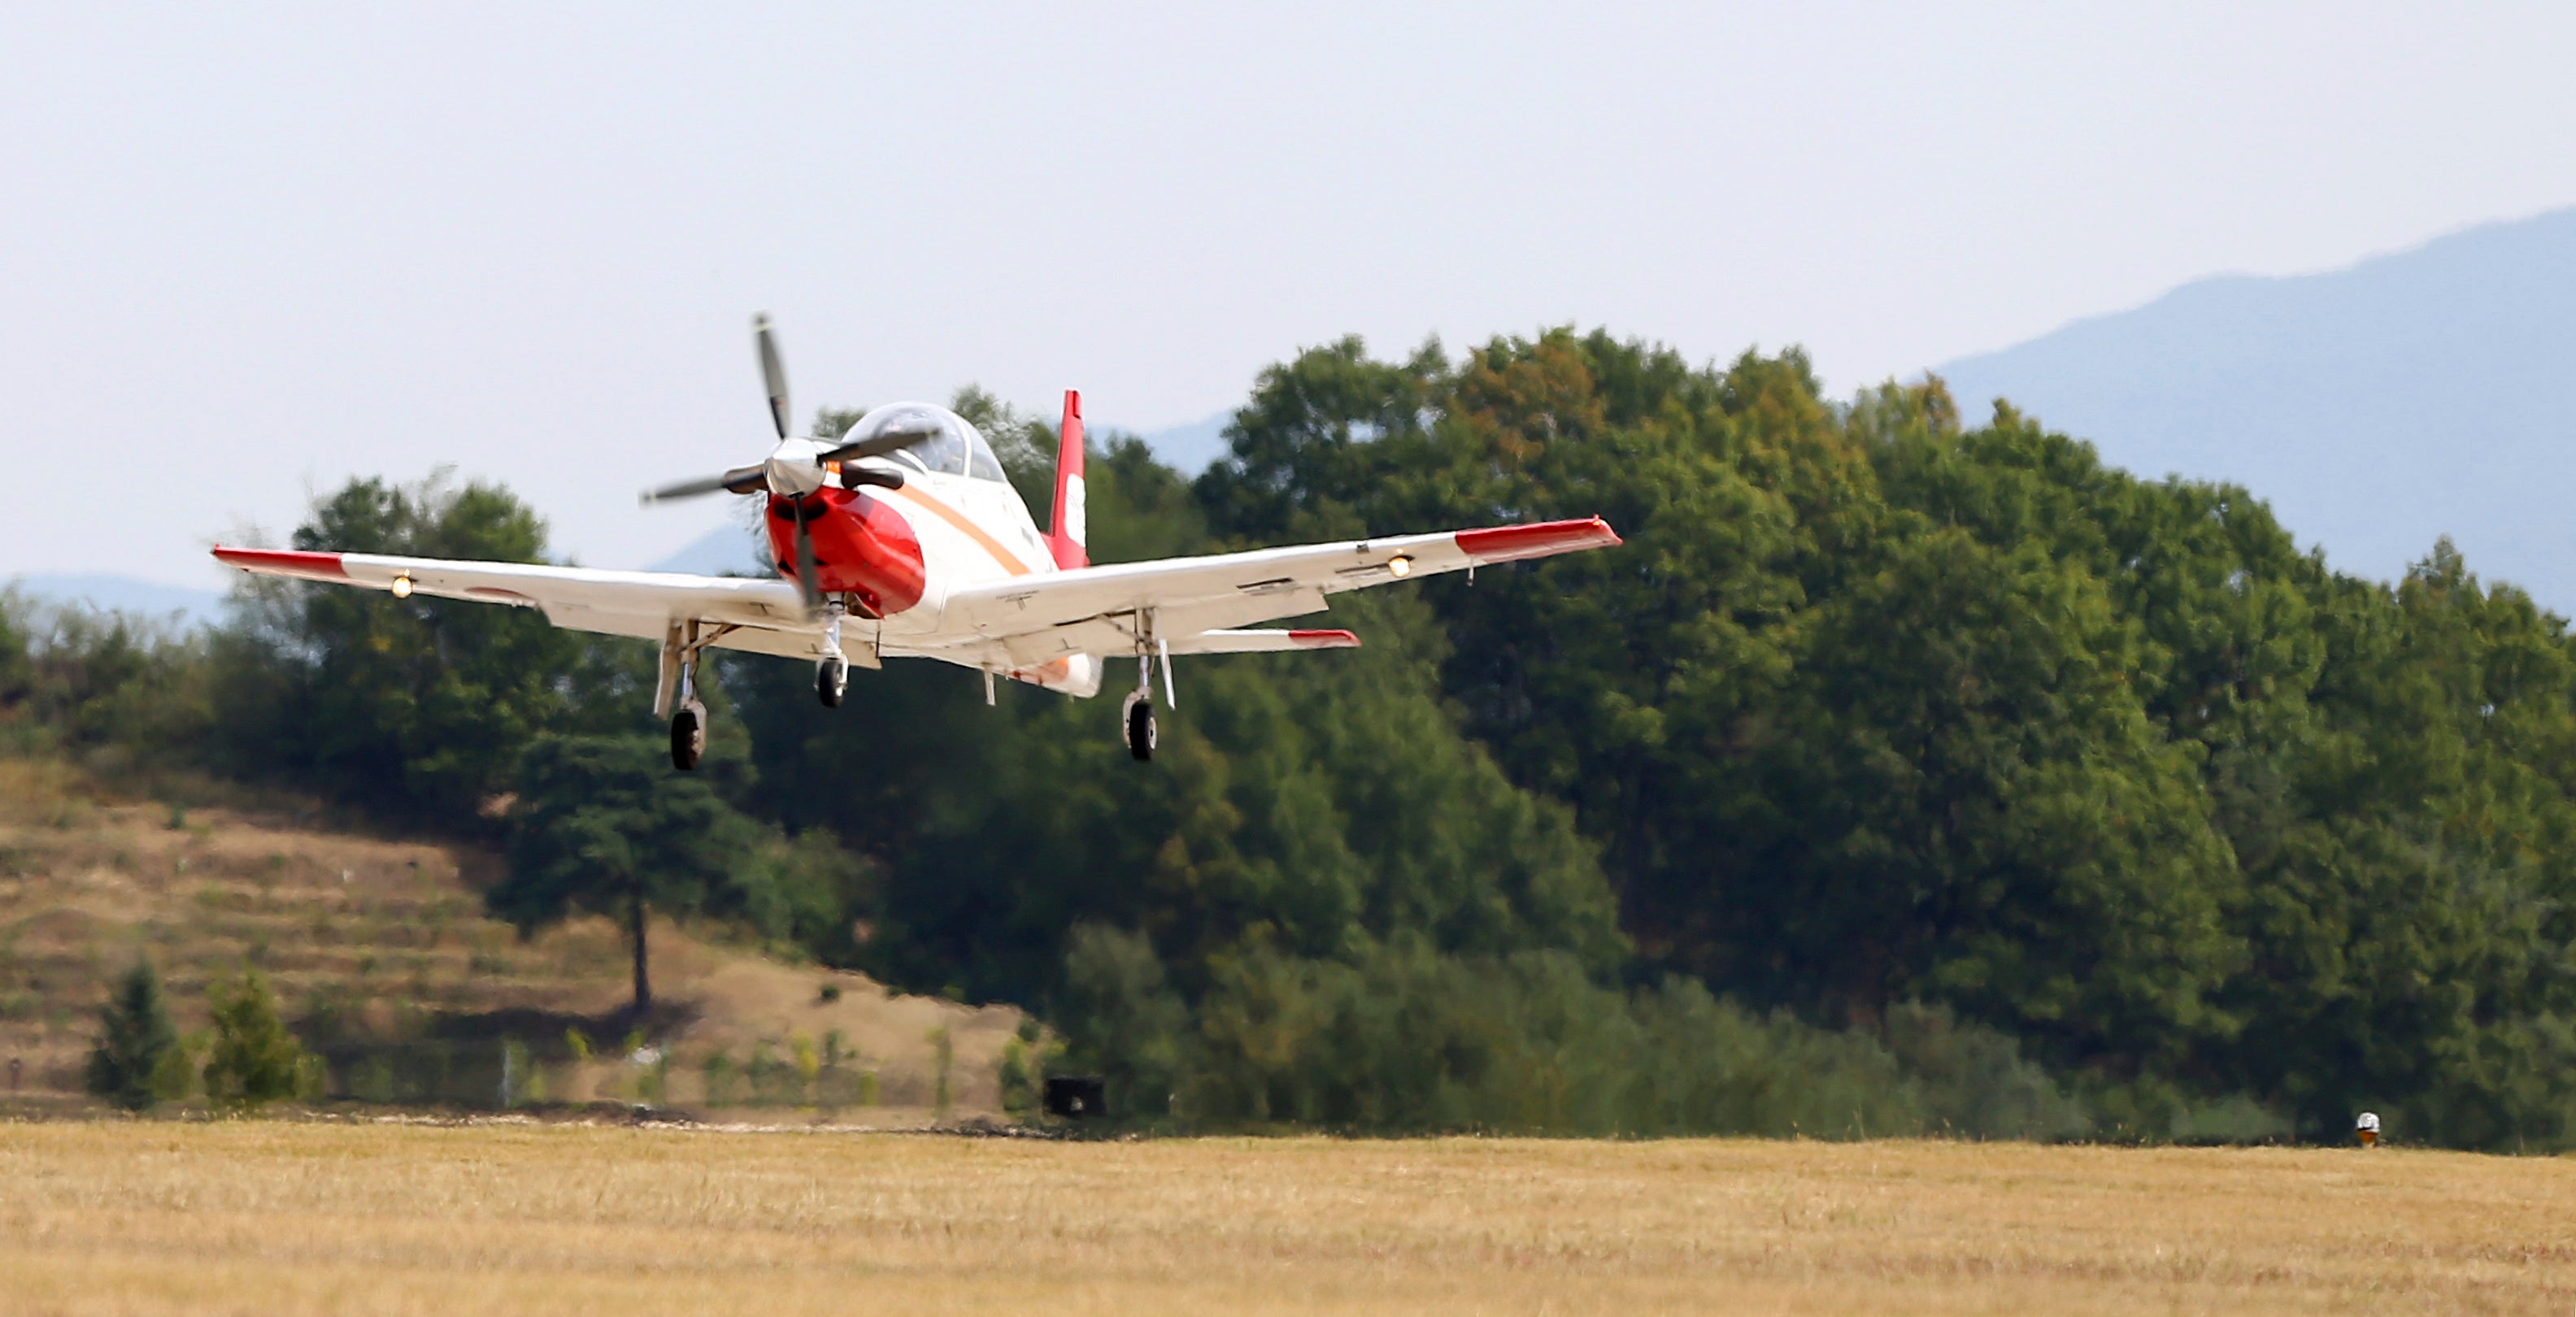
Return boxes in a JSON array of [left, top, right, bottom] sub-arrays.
[[0, 1121, 2576, 1317]]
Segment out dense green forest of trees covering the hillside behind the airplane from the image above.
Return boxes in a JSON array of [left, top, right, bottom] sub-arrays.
[[0, 333, 2576, 1147]]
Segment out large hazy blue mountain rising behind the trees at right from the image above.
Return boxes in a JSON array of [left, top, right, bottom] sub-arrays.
[[1937, 209, 2576, 614]]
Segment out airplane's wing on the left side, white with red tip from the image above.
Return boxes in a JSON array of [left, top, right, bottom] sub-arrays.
[[214, 546, 834, 663]]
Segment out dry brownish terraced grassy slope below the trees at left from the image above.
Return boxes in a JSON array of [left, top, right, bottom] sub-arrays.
[[0, 758, 1020, 1124]]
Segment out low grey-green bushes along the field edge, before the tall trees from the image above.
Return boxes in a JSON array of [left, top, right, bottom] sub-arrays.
[[1061, 925, 2089, 1139]]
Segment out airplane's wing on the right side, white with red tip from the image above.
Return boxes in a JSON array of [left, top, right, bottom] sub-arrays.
[[940, 518, 1621, 665]]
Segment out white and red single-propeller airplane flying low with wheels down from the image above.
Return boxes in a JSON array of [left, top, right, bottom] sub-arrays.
[[214, 317, 1621, 768]]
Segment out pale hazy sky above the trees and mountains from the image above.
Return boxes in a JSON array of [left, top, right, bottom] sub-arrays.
[[0, 0, 2576, 585]]
